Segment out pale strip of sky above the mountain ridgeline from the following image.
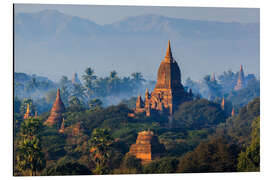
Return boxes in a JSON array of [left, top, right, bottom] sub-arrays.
[[15, 4, 260, 25]]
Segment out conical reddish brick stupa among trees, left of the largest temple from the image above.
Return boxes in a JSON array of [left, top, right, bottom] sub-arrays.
[[44, 89, 65, 126]]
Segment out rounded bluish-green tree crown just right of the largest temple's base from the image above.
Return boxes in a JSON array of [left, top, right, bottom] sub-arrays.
[[174, 99, 226, 129]]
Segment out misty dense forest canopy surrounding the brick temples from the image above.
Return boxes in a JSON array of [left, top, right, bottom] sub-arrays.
[[14, 68, 260, 175]]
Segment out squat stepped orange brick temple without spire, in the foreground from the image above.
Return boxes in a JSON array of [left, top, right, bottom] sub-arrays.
[[129, 130, 165, 164]]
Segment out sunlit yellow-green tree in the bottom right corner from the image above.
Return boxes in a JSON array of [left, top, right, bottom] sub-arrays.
[[237, 117, 260, 171]]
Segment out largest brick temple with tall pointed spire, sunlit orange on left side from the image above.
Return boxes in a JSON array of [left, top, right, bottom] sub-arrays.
[[130, 41, 193, 116]]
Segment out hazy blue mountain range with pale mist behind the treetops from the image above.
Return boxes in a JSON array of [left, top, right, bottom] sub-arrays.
[[14, 10, 260, 80]]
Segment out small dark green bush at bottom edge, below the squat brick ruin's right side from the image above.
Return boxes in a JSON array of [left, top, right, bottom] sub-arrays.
[[143, 157, 179, 174]]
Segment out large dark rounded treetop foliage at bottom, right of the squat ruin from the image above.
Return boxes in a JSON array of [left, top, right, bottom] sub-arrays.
[[177, 136, 239, 173]]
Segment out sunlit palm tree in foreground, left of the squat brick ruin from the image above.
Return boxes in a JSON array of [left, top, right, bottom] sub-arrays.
[[89, 128, 114, 174]]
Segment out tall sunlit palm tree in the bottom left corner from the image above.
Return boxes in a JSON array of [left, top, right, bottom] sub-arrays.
[[15, 118, 46, 176]]
